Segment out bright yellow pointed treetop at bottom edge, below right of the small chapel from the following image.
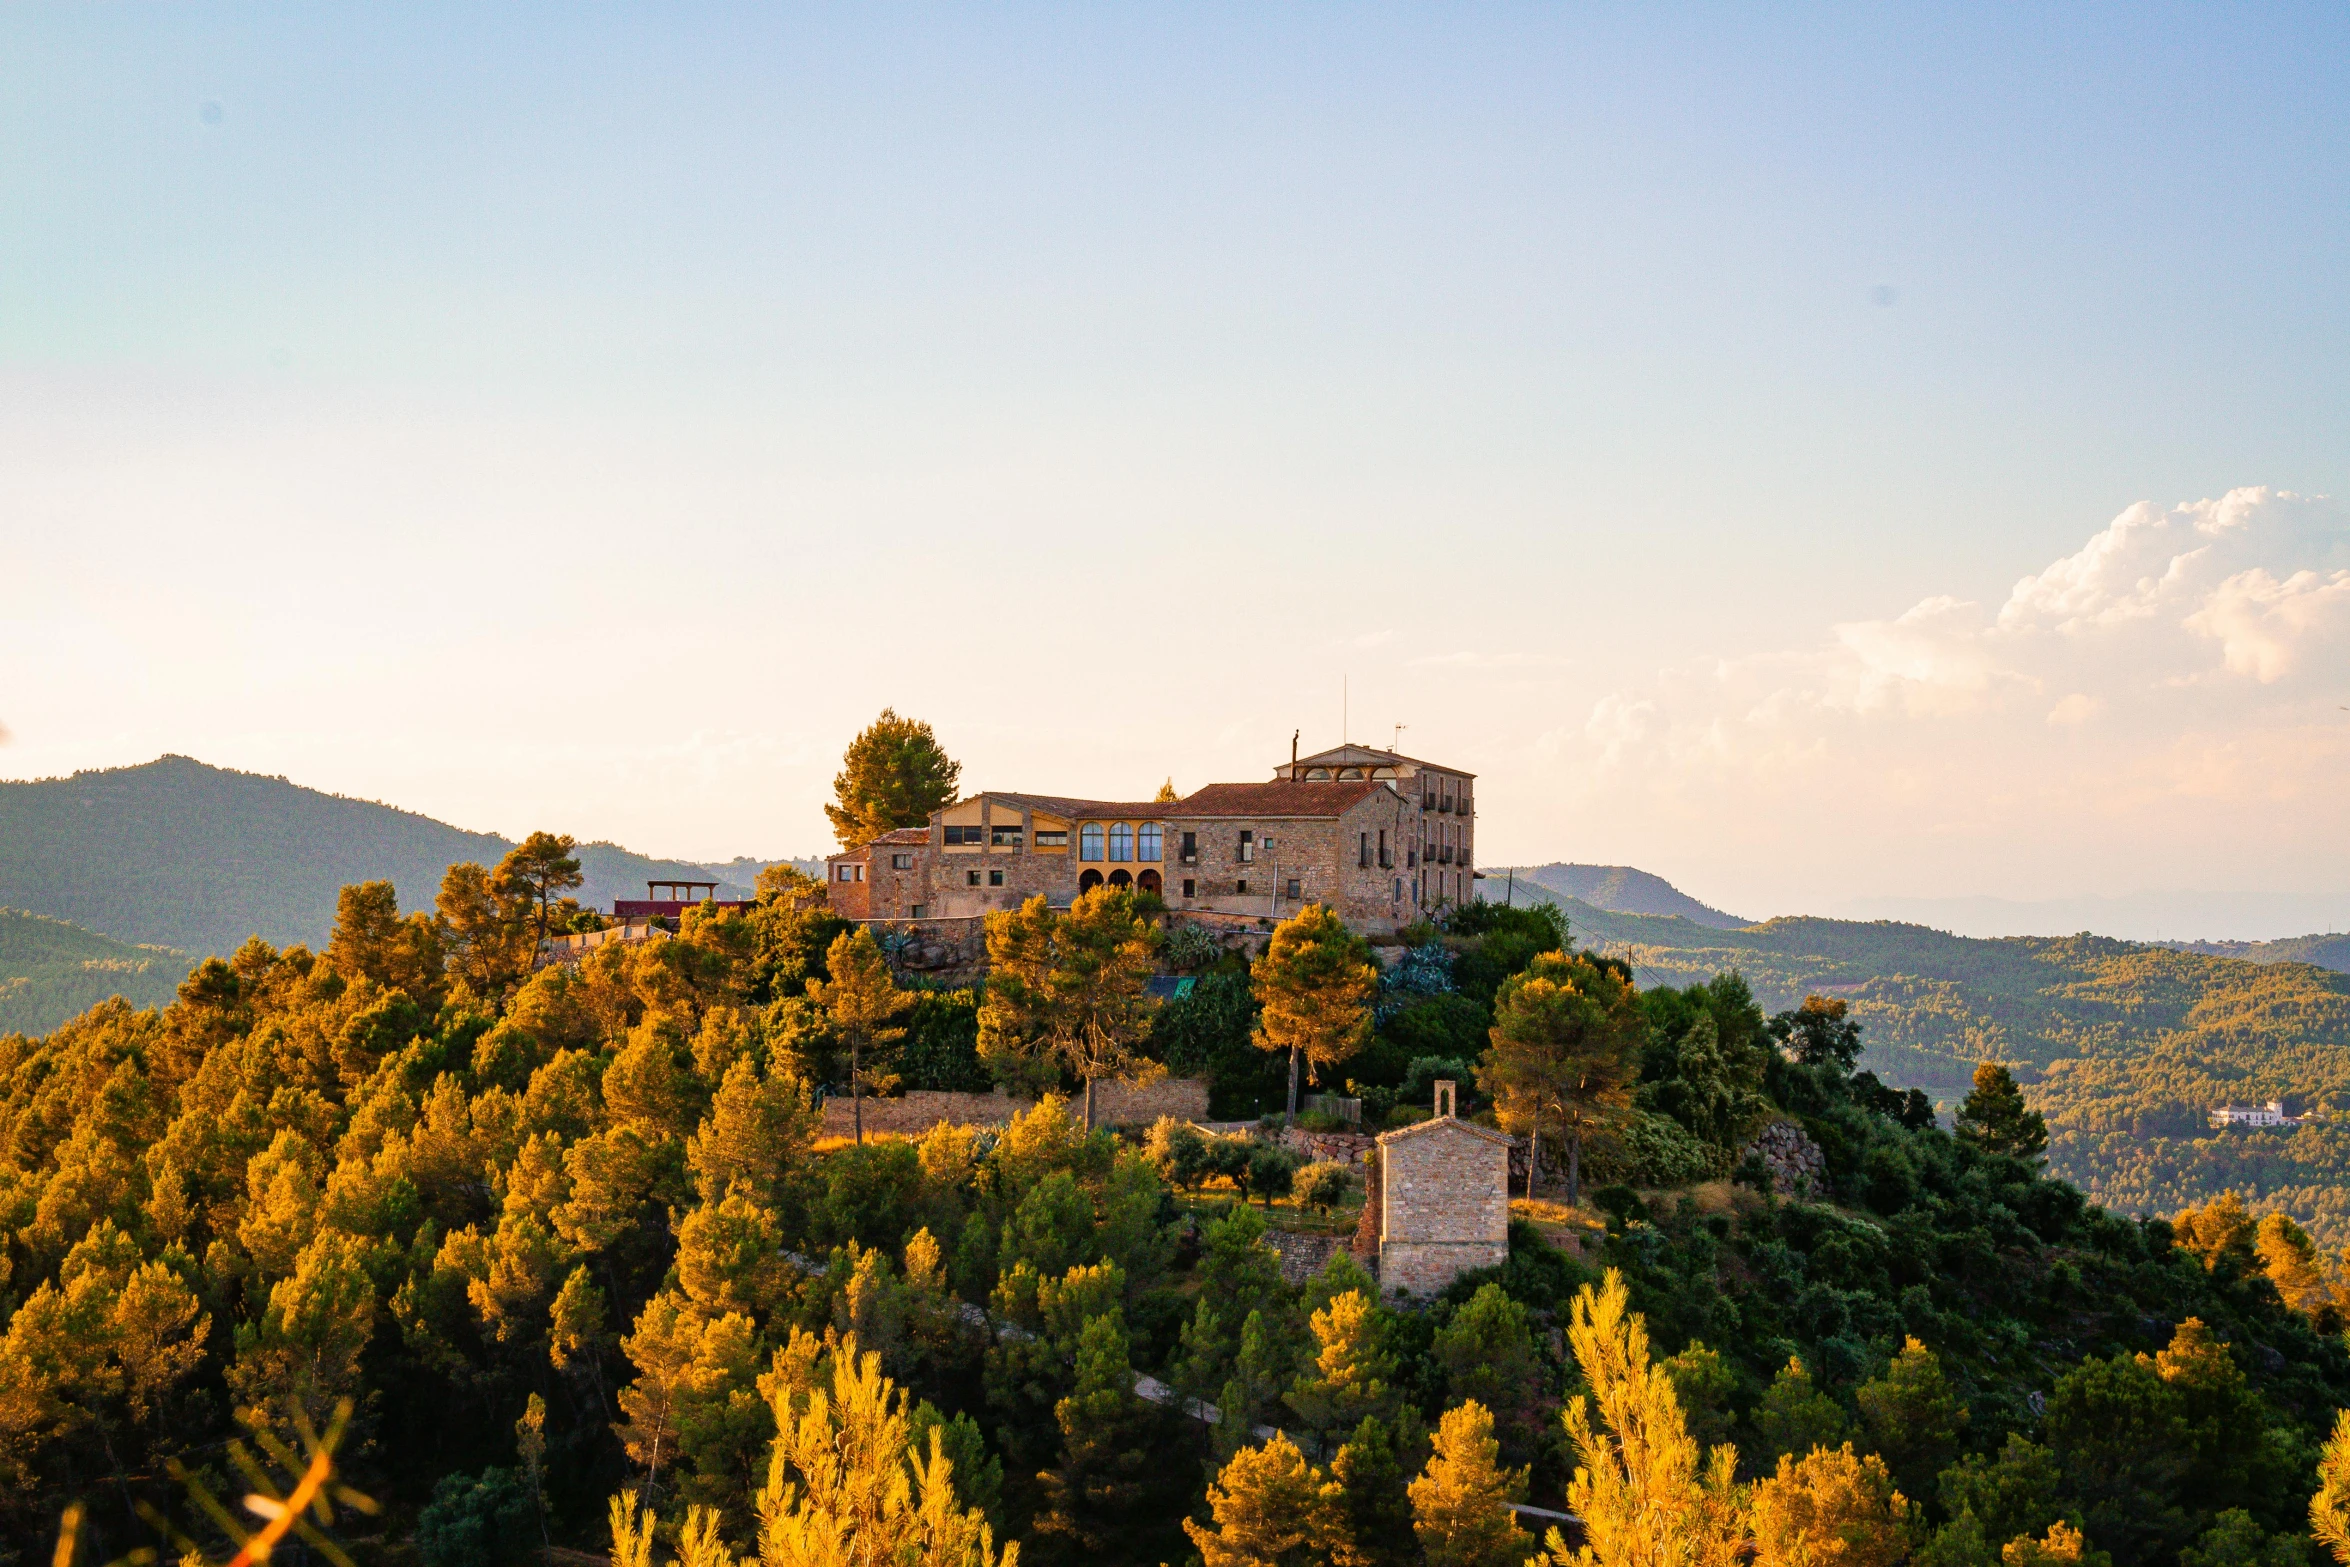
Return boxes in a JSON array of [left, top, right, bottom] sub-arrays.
[[1539, 1269, 1746, 1567]]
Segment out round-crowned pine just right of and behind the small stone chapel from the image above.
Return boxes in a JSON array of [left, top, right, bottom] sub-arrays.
[[1478, 951, 1643, 1203]]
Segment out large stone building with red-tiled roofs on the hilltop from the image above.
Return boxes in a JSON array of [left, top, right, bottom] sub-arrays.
[[827, 745, 1476, 928]]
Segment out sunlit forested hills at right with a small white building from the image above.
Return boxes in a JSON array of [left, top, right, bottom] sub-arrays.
[[1518, 883, 2350, 1245]]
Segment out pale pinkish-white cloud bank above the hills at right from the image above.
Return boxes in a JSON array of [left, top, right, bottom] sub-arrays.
[[1535, 489, 2350, 907]]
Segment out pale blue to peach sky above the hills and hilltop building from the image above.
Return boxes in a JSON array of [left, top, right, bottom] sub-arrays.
[[0, 2, 2350, 937]]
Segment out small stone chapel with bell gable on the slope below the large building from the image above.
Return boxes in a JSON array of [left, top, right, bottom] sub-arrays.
[[1372, 1083, 1511, 1297]]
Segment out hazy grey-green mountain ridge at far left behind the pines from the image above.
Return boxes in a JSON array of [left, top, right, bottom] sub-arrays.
[[0, 756, 747, 975]]
